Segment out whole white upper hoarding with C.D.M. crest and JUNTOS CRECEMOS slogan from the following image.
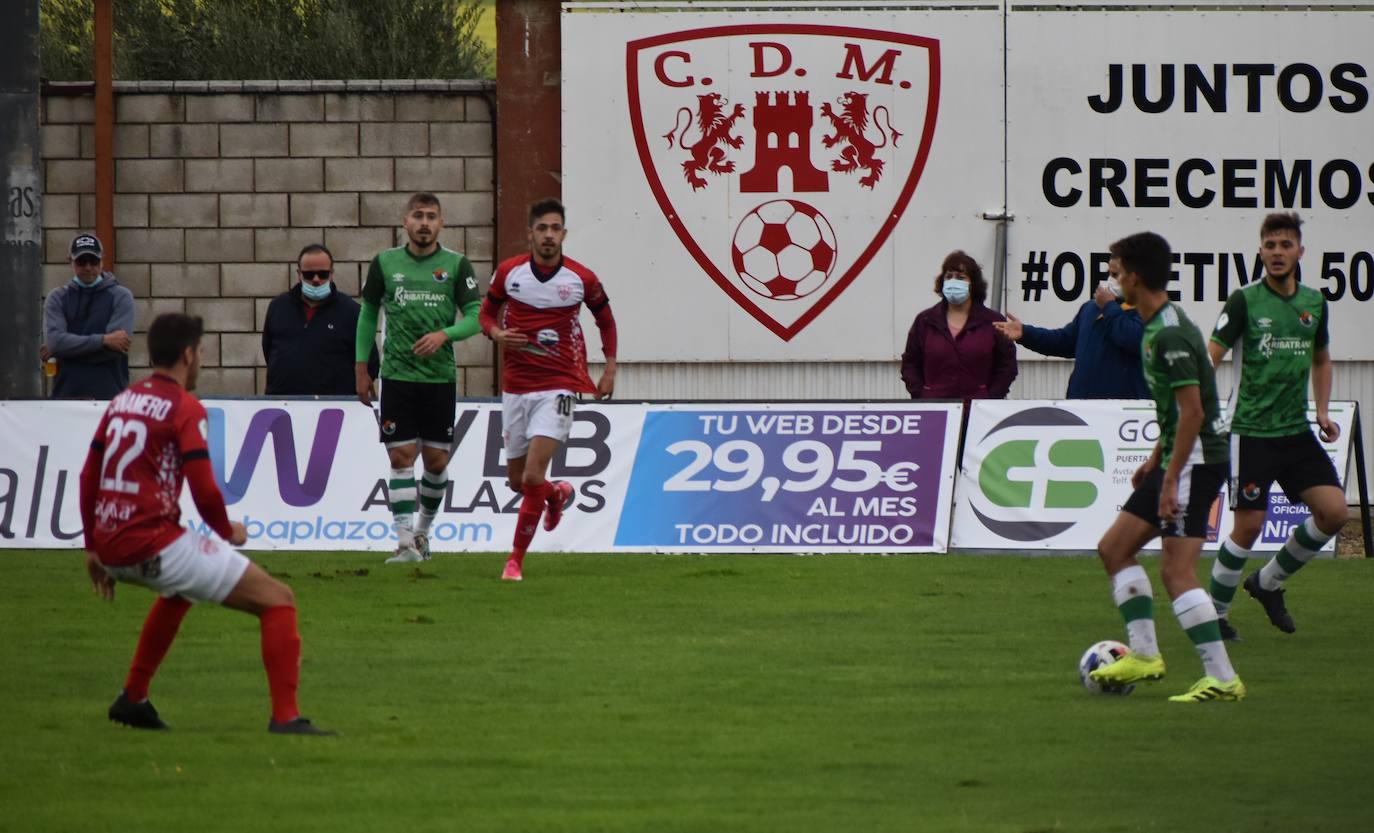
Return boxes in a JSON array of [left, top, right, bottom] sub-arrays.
[[561, 0, 1374, 362]]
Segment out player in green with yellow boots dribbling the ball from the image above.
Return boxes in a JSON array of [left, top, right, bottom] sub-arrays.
[[1091, 231, 1245, 702]]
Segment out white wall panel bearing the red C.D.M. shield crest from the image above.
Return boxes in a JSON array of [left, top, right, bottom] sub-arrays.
[[562, 4, 1003, 362]]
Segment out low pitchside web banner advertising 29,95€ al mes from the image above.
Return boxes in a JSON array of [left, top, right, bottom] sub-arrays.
[[0, 400, 962, 553]]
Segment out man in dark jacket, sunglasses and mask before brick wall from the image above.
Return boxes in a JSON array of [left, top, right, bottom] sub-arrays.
[[262, 243, 379, 396]]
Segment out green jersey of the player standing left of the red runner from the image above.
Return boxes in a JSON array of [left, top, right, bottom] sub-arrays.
[[354, 246, 481, 382]]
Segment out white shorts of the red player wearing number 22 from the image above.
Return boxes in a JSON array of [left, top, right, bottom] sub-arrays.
[[104, 529, 249, 603]]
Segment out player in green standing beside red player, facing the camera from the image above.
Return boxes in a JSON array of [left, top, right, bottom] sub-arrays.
[[353, 192, 481, 564]]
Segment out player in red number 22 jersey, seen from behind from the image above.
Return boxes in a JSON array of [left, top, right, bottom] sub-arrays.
[[81, 313, 333, 734]]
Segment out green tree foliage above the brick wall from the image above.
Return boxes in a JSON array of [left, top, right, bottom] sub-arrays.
[[40, 0, 492, 81]]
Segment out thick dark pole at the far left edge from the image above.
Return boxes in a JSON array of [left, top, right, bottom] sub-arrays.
[[0, 0, 43, 399]]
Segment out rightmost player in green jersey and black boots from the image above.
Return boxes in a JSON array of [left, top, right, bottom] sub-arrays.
[[1208, 213, 1349, 639]]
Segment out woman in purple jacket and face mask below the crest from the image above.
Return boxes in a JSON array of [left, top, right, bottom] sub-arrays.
[[901, 250, 1017, 399]]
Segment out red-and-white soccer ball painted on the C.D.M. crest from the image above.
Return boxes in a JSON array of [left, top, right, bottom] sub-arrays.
[[730, 199, 835, 301]]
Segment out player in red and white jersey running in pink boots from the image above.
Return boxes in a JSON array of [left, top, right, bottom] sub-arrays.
[[480, 199, 616, 581]]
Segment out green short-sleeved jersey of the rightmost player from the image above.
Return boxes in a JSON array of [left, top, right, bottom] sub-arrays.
[[1212, 280, 1330, 437]]
